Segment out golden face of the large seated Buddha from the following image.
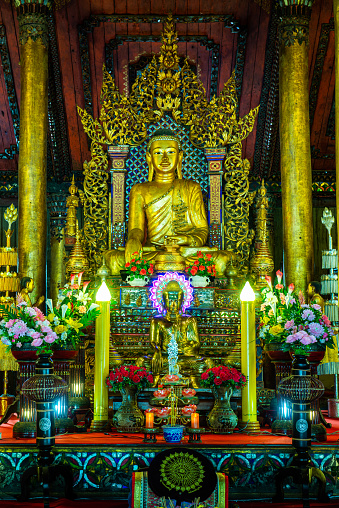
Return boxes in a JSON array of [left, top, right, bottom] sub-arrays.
[[146, 139, 183, 175]]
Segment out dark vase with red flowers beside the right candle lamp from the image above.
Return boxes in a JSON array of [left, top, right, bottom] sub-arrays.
[[201, 365, 246, 434]]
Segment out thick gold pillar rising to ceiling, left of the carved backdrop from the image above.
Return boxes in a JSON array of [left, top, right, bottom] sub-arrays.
[[15, 0, 49, 300]]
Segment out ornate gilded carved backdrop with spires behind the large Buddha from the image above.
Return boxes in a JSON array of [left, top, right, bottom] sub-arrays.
[[78, 16, 258, 270]]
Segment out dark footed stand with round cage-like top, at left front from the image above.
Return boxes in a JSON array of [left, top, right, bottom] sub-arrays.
[[20, 354, 73, 508]]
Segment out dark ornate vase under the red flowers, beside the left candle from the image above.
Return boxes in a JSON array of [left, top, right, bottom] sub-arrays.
[[113, 385, 145, 432]]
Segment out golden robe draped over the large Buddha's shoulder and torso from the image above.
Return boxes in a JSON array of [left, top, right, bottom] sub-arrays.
[[128, 180, 208, 247]]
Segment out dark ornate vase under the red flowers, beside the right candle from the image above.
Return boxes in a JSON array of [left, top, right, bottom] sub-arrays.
[[207, 386, 238, 434]]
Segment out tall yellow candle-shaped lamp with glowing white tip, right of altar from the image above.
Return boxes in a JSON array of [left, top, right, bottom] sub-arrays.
[[240, 282, 260, 432]]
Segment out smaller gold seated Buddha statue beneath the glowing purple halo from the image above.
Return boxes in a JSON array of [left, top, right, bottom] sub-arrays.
[[137, 280, 213, 388]]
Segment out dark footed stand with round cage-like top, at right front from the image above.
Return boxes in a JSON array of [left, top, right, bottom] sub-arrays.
[[272, 355, 328, 508]]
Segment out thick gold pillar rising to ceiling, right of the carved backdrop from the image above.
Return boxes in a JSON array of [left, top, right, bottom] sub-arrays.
[[279, 0, 313, 294]]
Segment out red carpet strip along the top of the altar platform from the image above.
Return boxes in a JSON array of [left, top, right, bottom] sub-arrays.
[[0, 419, 339, 444]]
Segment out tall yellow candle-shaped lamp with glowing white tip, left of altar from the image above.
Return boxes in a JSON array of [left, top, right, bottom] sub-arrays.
[[91, 265, 111, 432]]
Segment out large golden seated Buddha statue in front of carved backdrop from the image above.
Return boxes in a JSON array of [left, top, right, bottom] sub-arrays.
[[105, 129, 236, 277]]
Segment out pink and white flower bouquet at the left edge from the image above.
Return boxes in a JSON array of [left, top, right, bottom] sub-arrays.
[[0, 302, 58, 354]]
